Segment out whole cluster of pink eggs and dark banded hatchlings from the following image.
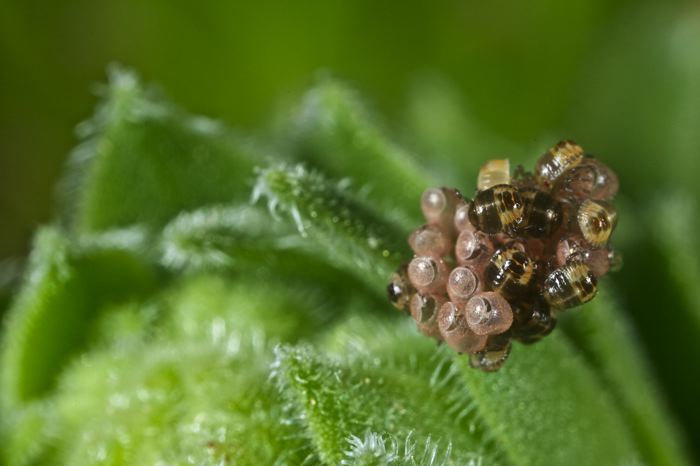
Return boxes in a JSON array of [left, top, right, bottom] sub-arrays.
[[388, 141, 620, 371]]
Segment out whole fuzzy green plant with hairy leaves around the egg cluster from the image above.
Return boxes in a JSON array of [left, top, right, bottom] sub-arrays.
[[0, 69, 700, 466]]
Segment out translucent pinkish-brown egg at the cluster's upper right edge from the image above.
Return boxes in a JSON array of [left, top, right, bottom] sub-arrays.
[[552, 157, 620, 202]]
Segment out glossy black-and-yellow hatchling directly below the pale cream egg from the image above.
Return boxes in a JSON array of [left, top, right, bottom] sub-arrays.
[[469, 184, 523, 234]]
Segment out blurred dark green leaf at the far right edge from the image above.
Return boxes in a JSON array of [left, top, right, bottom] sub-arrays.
[[616, 193, 700, 454]]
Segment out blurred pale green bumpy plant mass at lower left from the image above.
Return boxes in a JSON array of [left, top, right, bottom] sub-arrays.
[[8, 276, 348, 465]]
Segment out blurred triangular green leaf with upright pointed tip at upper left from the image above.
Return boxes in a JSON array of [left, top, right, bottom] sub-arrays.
[[63, 68, 262, 232]]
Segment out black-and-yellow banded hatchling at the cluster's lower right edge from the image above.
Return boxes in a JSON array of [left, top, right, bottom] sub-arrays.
[[543, 261, 598, 310]]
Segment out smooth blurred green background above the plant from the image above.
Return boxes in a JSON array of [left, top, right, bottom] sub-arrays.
[[0, 0, 700, 257]]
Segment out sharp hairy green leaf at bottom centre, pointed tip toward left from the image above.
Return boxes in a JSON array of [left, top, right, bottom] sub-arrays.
[[274, 318, 499, 465]]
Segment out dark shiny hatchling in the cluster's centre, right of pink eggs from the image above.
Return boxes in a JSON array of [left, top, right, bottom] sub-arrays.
[[484, 243, 535, 299]]
